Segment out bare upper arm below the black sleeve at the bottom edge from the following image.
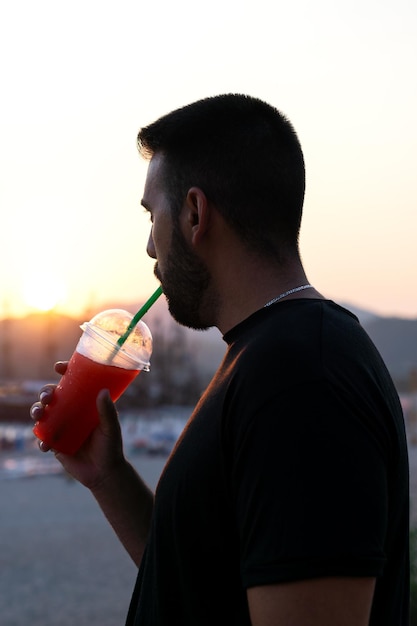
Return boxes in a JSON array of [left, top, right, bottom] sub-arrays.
[[247, 577, 375, 626]]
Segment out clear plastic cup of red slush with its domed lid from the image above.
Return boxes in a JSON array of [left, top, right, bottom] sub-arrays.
[[33, 309, 152, 454]]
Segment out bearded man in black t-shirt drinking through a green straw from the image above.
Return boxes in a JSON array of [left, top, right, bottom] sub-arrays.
[[32, 95, 409, 626]]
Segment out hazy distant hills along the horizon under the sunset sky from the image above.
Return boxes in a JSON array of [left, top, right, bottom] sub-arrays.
[[0, 297, 417, 384]]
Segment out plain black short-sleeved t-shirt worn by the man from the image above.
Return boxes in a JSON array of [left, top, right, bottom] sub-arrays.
[[127, 299, 409, 626]]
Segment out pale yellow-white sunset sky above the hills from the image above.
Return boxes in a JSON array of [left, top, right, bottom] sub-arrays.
[[0, 0, 417, 318]]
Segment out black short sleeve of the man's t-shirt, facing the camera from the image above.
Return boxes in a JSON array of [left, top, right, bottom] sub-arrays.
[[231, 381, 387, 587]]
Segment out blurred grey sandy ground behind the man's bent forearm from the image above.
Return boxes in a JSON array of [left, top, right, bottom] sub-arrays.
[[0, 446, 417, 626]]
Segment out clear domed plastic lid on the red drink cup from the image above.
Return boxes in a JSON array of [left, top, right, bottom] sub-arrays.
[[77, 309, 152, 371]]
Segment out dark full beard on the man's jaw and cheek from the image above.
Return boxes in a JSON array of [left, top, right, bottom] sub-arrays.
[[154, 225, 214, 330]]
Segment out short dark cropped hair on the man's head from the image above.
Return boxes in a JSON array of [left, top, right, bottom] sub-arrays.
[[138, 94, 305, 261]]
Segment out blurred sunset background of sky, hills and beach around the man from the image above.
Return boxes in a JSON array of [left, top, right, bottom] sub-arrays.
[[0, 0, 417, 626]]
